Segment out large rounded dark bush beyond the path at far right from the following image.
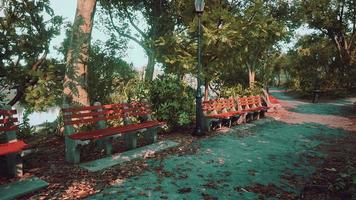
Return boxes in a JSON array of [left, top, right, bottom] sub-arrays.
[[284, 34, 349, 93]]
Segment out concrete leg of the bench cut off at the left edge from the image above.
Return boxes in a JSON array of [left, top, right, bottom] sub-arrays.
[[5, 153, 23, 177]]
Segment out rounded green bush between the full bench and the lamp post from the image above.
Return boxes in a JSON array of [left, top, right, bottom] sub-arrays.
[[149, 74, 195, 128]]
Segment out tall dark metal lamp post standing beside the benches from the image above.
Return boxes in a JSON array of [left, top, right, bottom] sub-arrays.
[[195, 0, 205, 136]]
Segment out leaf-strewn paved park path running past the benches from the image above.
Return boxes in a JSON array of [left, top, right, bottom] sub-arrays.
[[90, 91, 353, 199]]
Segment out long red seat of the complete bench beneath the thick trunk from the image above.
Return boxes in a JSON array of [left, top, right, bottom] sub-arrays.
[[69, 120, 165, 140]]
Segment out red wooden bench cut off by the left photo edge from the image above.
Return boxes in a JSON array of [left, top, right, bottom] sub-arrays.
[[0, 109, 28, 176]]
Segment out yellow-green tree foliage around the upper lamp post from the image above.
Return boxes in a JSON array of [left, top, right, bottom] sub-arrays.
[[156, 0, 289, 90]]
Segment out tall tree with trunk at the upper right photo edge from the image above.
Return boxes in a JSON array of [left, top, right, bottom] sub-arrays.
[[295, 0, 356, 87]]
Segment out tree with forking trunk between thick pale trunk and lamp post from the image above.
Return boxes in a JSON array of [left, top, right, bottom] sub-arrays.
[[101, 0, 175, 81]]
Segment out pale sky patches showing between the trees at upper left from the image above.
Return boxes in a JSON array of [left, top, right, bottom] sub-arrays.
[[49, 0, 147, 69]]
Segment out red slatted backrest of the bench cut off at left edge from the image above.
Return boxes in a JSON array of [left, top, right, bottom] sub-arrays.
[[0, 109, 18, 132]]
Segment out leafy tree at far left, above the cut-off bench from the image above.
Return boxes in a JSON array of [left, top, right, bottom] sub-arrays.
[[0, 0, 62, 106]]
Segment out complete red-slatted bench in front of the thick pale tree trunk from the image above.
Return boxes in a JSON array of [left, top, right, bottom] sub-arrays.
[[62, 102, 165, 163]]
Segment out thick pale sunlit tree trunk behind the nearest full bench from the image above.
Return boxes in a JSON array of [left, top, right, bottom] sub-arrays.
[[63, 0, 96, 106]]
